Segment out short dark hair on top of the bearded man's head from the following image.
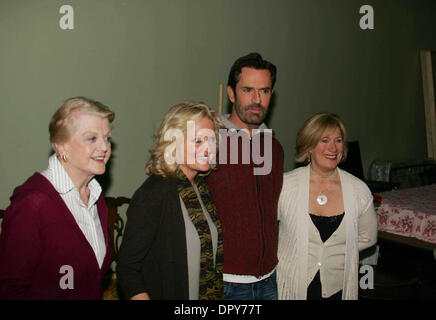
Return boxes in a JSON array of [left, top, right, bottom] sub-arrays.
[[227, 52, 277, 91]]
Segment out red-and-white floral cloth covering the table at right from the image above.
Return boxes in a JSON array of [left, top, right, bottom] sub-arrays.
[[374, 184, 436, 243]]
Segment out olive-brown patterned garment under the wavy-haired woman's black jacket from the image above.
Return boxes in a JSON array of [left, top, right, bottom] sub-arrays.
[[177, 170, 224, 300]]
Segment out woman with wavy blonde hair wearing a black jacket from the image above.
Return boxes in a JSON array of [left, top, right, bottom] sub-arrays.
[[117, 102, 223, 300]]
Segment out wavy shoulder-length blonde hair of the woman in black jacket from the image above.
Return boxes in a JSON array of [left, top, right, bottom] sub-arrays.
[[145, 101, 224, 178]]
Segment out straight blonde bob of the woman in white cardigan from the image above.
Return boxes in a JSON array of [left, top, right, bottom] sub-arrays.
[[295, 113, 348, 163]]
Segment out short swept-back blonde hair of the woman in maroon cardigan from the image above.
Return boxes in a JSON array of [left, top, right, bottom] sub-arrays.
[[48, 97, 115, 145]]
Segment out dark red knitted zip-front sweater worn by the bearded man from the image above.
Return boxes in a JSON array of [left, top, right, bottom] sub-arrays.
[[206, 131, 283, 277]]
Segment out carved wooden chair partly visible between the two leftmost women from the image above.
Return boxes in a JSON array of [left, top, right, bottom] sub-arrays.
[[103, 197, 130, 300]]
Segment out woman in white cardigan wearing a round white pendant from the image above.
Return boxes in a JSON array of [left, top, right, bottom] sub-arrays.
[[277, 113, 377, 300]]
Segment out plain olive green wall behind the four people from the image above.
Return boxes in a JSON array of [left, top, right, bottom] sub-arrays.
[[0, 0, 436, 208]]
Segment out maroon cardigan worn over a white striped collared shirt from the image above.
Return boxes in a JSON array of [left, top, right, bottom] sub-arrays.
[[0, 173, 112, 300]]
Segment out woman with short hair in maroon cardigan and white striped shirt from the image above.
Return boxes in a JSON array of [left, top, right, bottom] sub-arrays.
[[0, 97, 115, 300]]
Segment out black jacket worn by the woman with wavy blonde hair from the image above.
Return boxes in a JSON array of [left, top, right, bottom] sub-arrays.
[[117, 175, 189, 300]]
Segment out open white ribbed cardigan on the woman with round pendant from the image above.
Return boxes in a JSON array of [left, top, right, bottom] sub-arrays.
[[277, 166, 377, 300]]
